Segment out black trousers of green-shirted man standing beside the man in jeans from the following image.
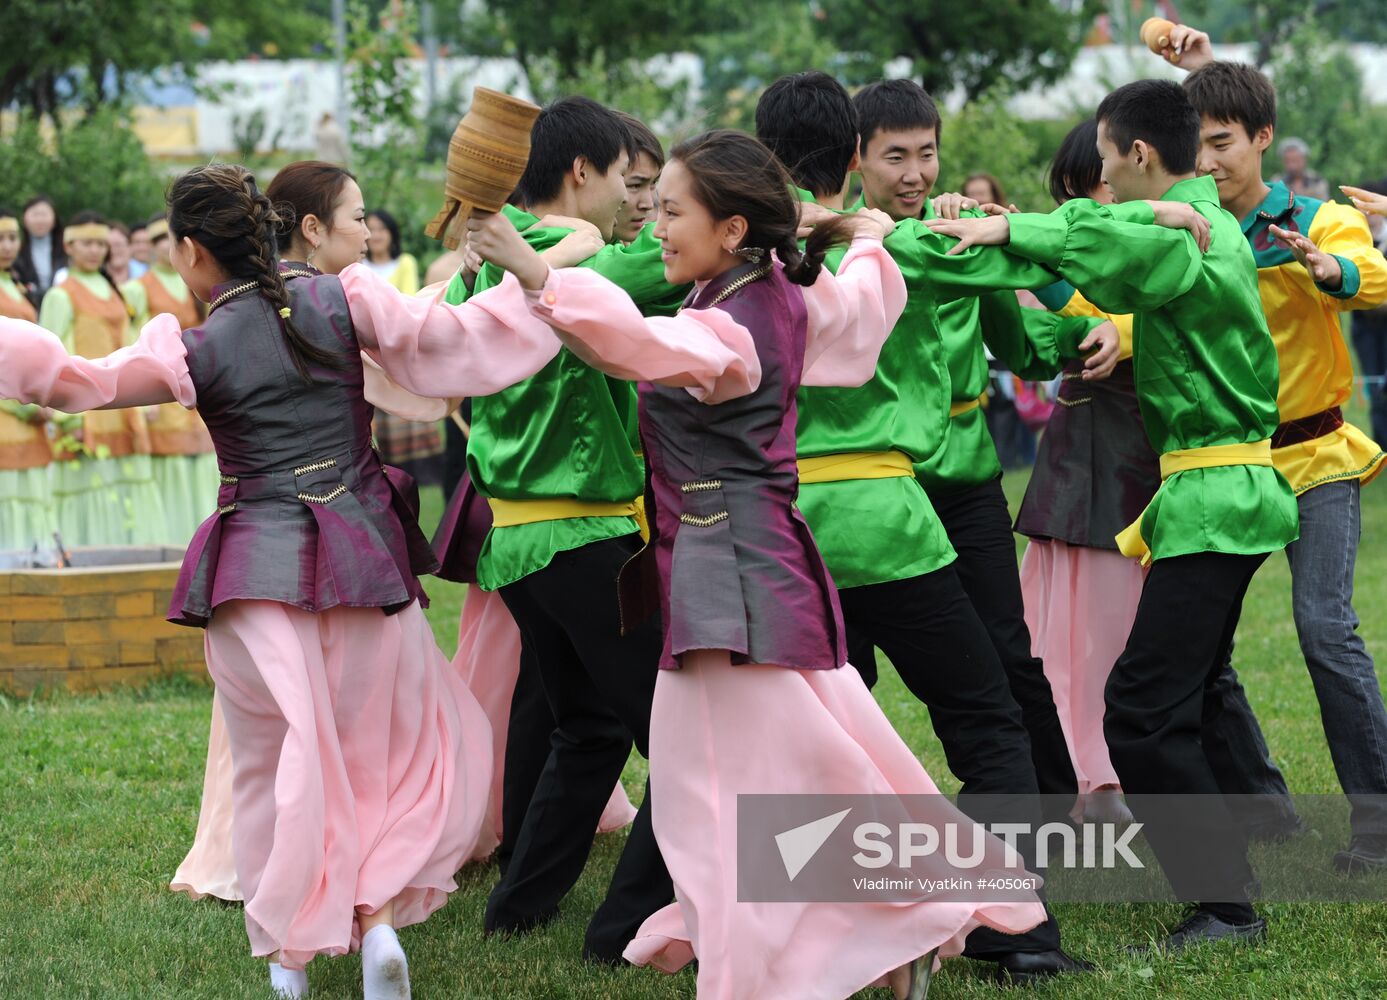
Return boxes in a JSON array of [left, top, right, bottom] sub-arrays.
[[1103, 552, 1266, 918]]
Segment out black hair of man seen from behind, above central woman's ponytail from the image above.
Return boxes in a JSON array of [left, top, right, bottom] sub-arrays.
[[756, 69, 859, 197]]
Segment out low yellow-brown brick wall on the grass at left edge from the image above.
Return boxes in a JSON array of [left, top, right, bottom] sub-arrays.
[[0, 563, 207, 696]]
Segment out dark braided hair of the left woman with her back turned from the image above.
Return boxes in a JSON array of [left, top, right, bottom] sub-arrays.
[[168, 164, 347, 381]]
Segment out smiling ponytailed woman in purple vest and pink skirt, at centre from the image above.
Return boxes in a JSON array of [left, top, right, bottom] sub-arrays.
[[473, 132, 1044, 1000]]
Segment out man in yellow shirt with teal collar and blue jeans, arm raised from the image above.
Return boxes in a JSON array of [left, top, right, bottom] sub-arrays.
[[1172, 48, 1387, 872]]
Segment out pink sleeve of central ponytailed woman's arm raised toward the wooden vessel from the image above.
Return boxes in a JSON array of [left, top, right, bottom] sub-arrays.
[[530, 268, 761, 404]]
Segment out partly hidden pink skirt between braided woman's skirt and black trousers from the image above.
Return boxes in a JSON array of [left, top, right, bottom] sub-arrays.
[[452, 587, 635, 860]]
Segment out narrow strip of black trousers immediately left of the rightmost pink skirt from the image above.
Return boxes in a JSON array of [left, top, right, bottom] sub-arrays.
[[929, 479, 1079, 818]]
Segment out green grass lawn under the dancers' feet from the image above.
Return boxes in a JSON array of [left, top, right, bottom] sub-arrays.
[[0, 457, 1387, 1000]]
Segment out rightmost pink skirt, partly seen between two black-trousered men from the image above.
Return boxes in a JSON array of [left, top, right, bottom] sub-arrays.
[[1021, 541, 1146, 795]]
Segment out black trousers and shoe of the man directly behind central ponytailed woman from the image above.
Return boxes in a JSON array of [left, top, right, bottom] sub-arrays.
[[838, 566, 1060, 958]]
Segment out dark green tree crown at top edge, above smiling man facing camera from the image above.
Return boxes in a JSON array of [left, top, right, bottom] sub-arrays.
[[817, 0, 1103, 97]]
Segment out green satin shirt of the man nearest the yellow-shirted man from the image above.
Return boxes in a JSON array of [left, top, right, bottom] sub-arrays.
[[1007, 178, 1300, 559]]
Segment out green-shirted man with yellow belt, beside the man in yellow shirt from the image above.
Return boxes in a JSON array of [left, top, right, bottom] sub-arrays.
[[931, 80, 1297, 951]]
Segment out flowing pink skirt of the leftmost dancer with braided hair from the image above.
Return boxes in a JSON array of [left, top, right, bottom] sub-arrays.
[[207, 601, 491, 968]]
